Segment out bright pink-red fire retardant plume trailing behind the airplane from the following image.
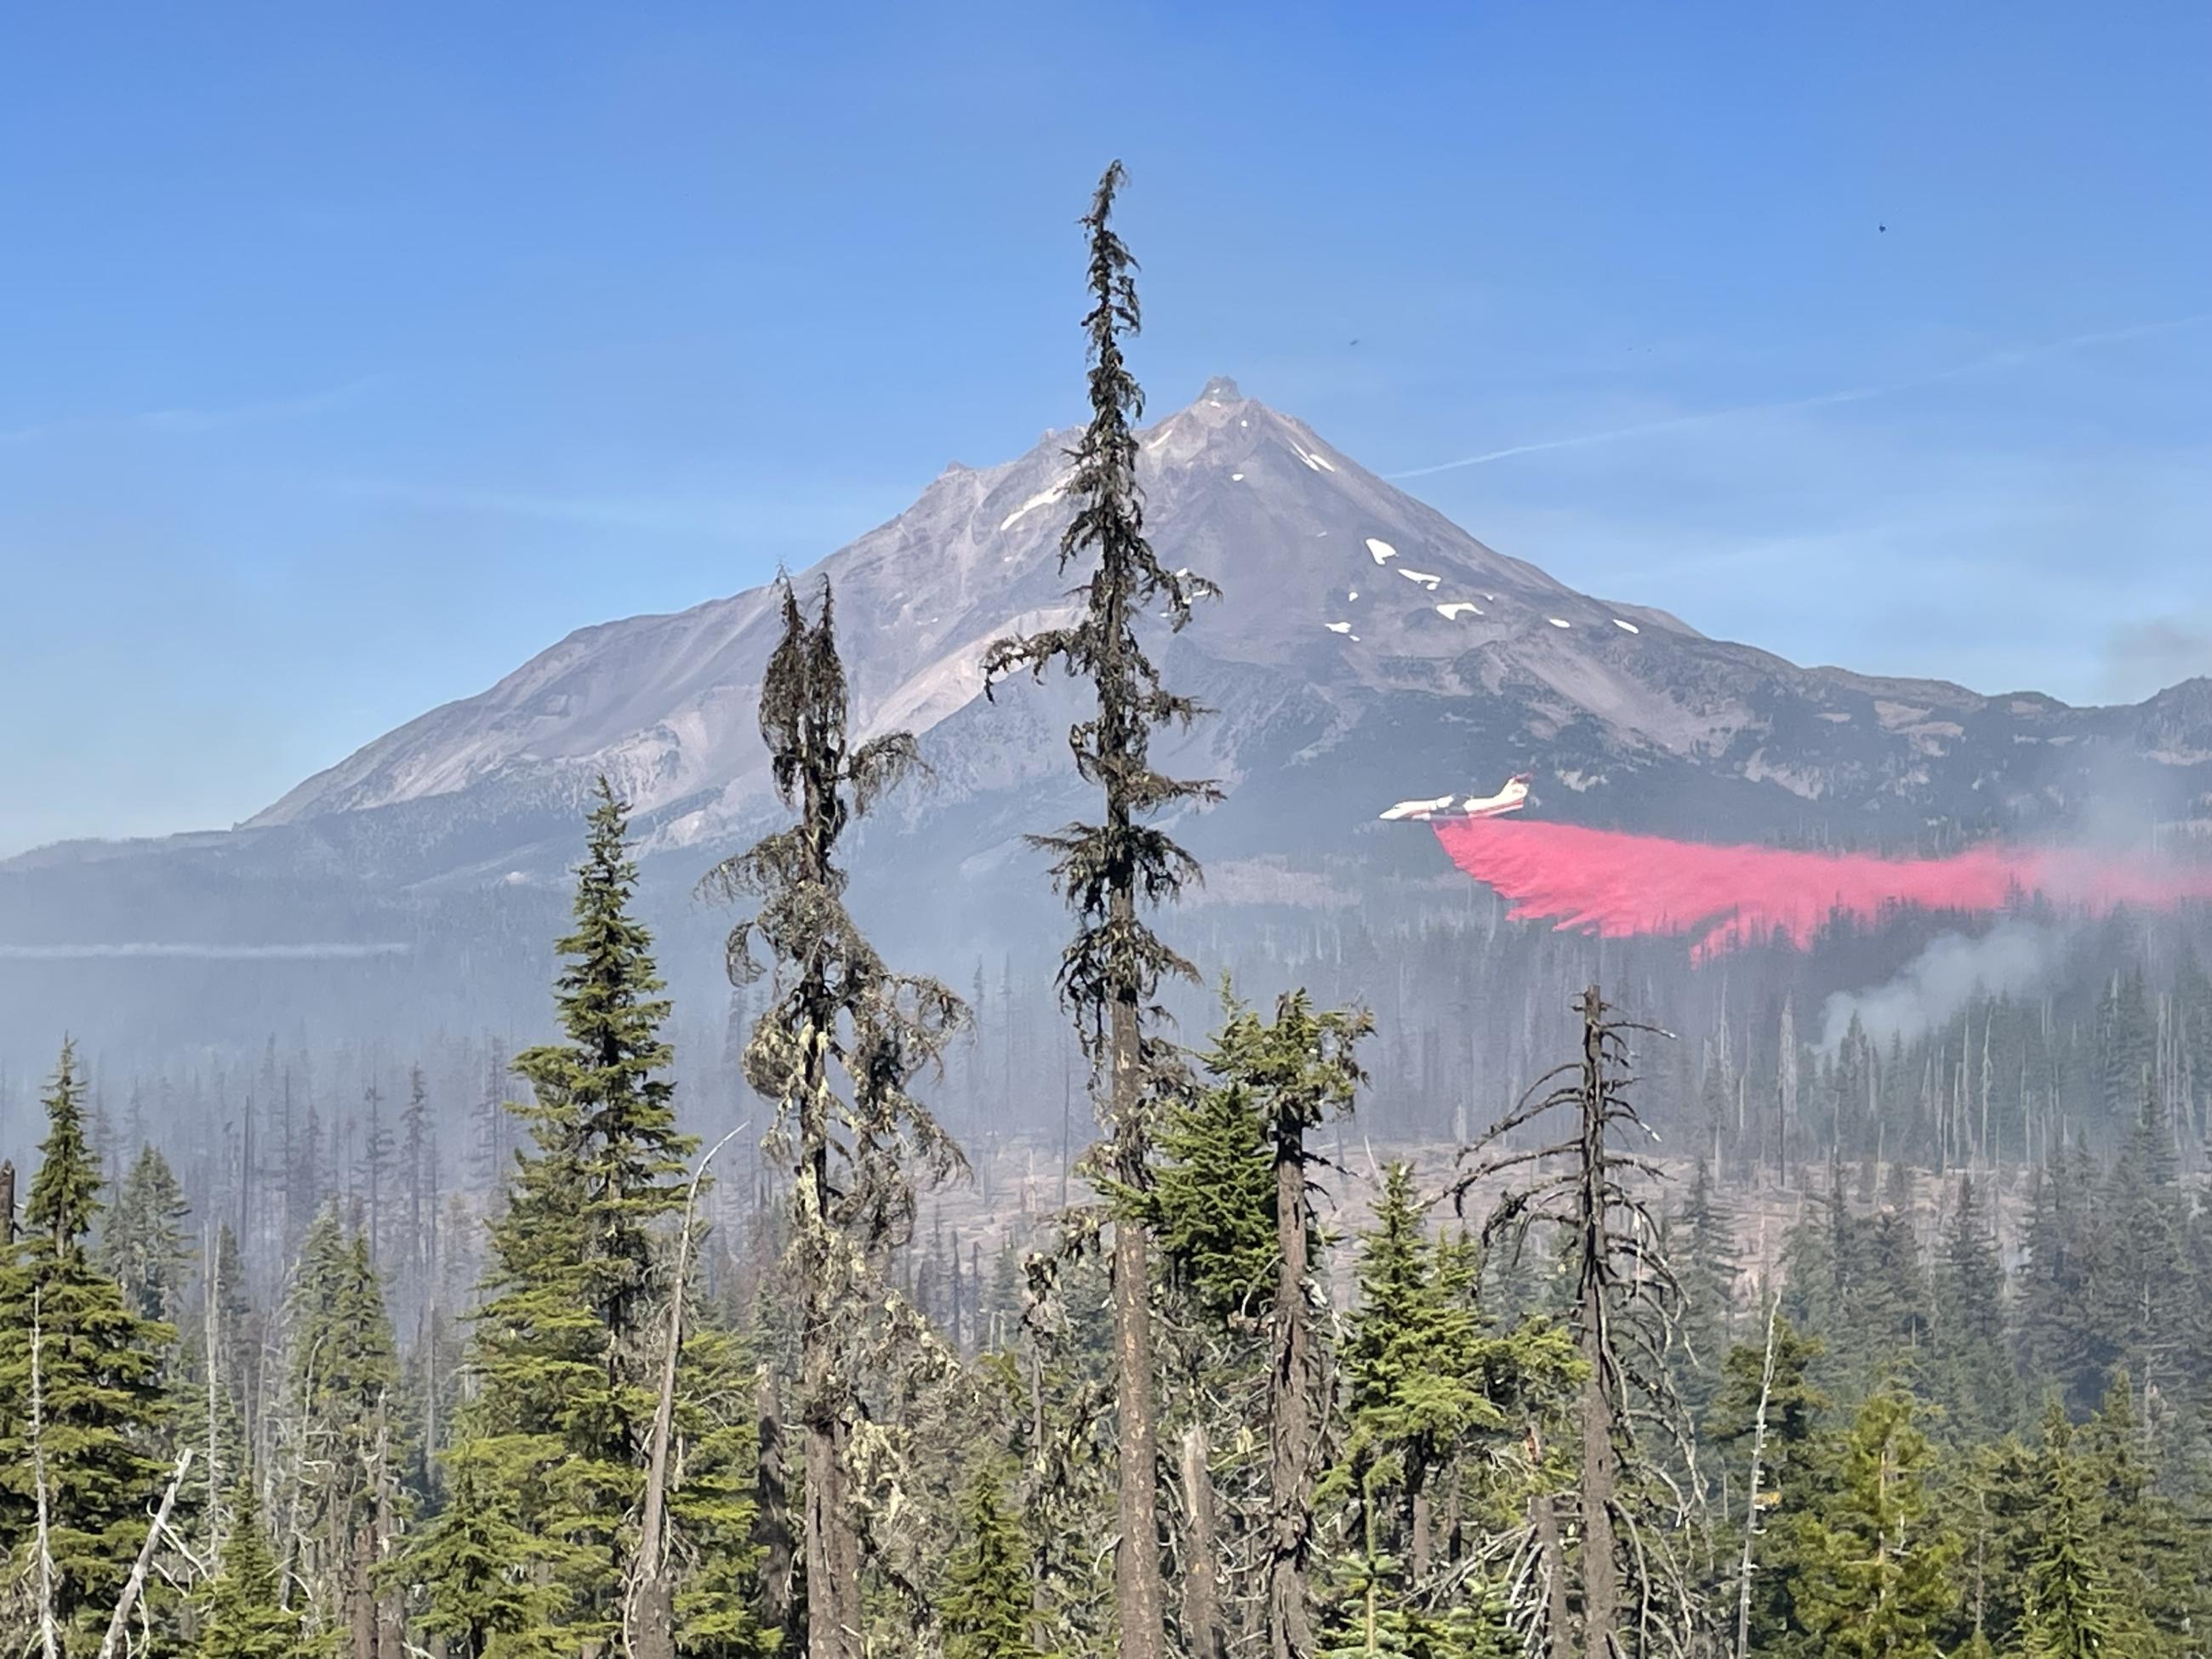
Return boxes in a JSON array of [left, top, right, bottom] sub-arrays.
[[1435, 818, 2212, 960]]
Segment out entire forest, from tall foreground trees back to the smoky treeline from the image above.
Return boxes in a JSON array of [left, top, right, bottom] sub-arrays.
[[0, 168, 2212, 1659]]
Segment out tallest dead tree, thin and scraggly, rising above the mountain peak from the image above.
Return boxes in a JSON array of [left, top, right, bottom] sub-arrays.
[[984, 162, 1219, 1659]]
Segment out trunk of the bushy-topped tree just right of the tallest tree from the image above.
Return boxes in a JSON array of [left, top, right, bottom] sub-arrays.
[[1268, 1117, 1314, 1659]]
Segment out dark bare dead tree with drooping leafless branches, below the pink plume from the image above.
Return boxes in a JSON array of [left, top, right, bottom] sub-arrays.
[[1451, 984, 1696, 1659]]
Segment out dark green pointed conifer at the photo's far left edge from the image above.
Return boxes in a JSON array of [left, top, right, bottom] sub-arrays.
[[0, 1044, 174, 1659]]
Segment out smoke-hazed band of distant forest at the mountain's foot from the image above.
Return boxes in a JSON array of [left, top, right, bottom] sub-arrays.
[[21, 889, 2212, 1256]]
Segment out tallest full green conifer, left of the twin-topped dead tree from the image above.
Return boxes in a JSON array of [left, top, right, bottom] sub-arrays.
[[425, 778, 694, 1650]]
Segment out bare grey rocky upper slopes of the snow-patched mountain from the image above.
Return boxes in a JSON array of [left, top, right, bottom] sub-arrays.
[[233, 380, 2212, 878]]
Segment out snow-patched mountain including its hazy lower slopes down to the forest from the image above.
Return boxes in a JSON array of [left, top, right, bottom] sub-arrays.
[[0, 380, 2212, 1052]]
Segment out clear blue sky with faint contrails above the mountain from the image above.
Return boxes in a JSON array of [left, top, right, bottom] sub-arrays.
[[0, 0, 2212, 852]]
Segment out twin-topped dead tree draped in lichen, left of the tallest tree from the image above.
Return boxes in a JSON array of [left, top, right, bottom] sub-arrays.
[[701, 582, 966, 1659]]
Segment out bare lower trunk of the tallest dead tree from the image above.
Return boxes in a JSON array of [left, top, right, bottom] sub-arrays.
[[1109, 968, 1166, 1659]]
